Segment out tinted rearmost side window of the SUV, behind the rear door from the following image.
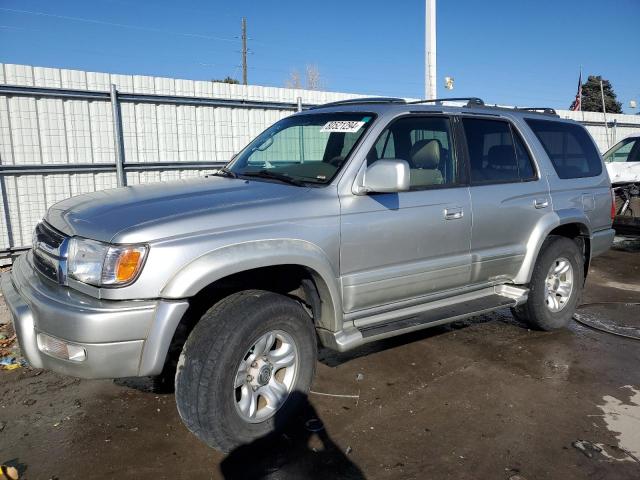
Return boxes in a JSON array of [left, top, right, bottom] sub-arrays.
[[526, 119, 602, 179]]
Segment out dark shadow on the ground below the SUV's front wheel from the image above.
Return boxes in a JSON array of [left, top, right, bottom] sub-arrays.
[[220, 391, 365, 480]]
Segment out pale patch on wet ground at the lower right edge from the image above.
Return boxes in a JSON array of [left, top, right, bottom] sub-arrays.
[[598, 385, 640, 462]]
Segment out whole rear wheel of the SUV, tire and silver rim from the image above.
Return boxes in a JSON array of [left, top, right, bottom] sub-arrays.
[[511, 236, 584, 331]]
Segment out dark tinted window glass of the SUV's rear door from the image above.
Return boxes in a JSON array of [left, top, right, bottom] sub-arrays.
[[462, 117, 535, 184]]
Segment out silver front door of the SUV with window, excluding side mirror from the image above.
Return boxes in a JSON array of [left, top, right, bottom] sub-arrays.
[[340, 115, 471, 313]]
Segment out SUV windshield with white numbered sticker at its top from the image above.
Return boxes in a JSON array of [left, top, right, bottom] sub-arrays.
[[228, 113, 374, 185]]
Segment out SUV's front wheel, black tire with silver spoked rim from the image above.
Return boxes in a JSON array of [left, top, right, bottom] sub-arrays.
[[176, 290, 317, 452]]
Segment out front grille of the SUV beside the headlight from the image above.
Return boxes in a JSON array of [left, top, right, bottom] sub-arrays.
[[33, 222, 67, 283]]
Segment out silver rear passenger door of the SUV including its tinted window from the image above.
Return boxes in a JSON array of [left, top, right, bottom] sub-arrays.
[[461, 116, 551, 284]]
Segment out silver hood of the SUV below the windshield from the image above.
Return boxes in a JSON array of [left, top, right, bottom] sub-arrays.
[[45, 177, 308, 242]]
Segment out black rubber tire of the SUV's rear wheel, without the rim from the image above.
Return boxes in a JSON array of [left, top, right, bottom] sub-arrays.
[[511, 236, 584, 331]]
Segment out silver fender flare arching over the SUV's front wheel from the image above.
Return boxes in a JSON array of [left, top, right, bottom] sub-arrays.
[[160, 239, 342, 331]]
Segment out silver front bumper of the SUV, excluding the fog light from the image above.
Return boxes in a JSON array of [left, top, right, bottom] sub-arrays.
[[1, 252, 188, 378]]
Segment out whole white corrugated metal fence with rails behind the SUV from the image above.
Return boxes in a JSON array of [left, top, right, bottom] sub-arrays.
[[0, 64, 640, 262]]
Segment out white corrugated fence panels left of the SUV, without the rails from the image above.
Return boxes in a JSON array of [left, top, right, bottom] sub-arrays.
[[0, 64, 358, 250]]
